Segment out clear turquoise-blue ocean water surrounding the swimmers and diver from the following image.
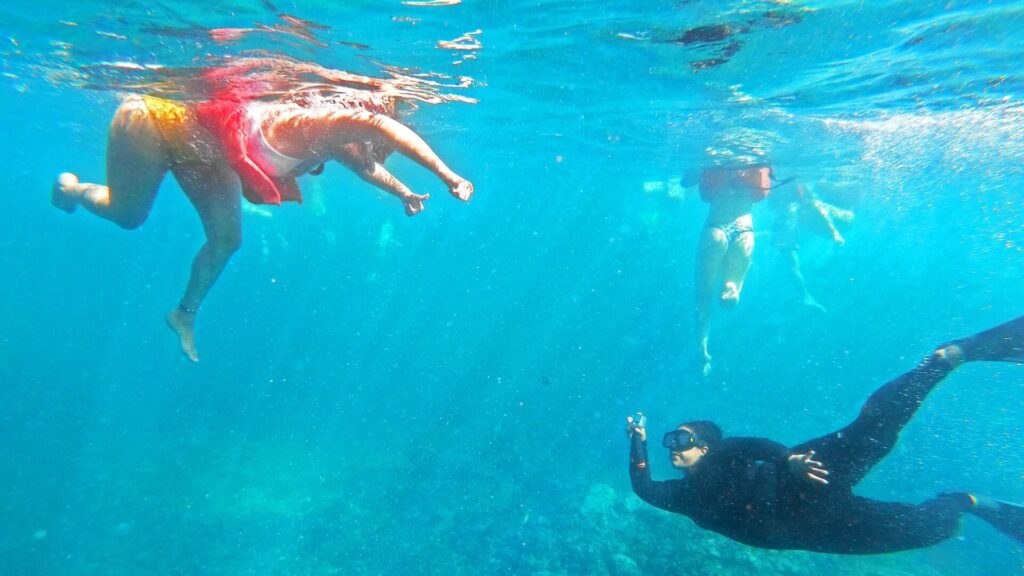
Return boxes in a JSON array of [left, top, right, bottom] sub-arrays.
[[0, 0, 1024, 575]]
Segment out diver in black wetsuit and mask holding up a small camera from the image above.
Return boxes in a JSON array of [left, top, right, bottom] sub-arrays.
[[627, 317, 1024, 554]]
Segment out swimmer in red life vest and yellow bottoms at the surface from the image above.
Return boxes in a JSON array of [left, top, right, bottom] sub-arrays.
[[51, 60, 473, 362]]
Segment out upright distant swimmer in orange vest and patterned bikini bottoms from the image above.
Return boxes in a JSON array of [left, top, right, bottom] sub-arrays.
[[684, 165, 772, 375]]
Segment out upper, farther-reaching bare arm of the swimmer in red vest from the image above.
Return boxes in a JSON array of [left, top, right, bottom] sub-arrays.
[[336, 111, 473, 202]]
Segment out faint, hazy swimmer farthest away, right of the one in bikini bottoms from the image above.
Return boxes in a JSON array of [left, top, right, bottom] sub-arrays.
[[768, 184, 854, 312]]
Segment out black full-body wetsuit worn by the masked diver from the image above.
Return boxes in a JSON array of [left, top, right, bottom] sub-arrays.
[[630, 355, 971, 554]]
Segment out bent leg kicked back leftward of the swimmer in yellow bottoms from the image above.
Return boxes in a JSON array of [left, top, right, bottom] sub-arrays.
[[51, 96, 170, 229]]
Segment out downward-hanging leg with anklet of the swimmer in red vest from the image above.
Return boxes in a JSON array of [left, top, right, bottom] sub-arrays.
[[167, 164, 242, 362]]
